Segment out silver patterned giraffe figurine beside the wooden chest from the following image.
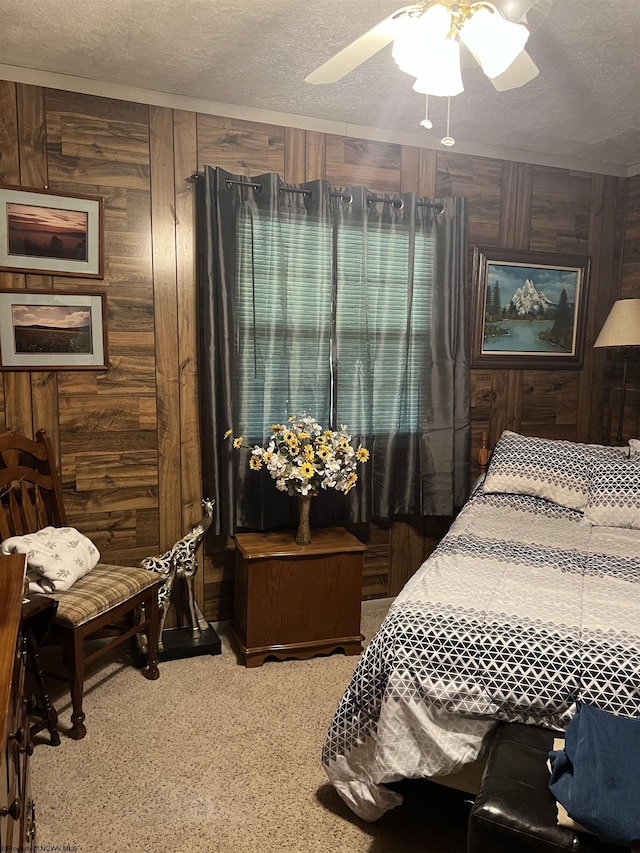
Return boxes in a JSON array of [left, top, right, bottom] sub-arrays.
[[138, 498, 215, 652]]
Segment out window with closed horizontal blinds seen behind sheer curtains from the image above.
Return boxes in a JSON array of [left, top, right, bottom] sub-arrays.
[[236, 205, 434, 442]]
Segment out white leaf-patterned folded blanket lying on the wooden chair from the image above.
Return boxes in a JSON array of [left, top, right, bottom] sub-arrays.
[[0, 527, 100, 593]]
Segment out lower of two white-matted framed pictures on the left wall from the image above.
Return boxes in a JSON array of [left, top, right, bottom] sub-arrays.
[[0, 290, 108, 370]]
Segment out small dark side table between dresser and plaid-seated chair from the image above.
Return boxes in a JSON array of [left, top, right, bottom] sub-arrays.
[[22, 595, 60, 746]]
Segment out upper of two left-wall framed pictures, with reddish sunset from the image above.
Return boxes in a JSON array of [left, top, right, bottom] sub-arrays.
[[0, 186, 104, 278]]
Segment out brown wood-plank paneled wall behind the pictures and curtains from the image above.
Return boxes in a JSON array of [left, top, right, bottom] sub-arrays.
[[0, 81, 640, 619]]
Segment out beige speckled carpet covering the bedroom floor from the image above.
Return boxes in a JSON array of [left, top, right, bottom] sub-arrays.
[[31, 603, 469, 853]]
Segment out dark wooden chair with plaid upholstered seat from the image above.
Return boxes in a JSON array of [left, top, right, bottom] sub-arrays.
[[0, 430, 160, 740]]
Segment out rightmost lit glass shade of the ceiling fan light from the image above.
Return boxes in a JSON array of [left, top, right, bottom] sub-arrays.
[[460, 3, 529, 79]]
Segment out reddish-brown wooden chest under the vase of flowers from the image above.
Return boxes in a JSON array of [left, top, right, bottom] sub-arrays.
[[231, 527, 366, 666]]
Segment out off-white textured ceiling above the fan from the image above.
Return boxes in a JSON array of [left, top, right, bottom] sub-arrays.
[[0, 0, 640, 174]]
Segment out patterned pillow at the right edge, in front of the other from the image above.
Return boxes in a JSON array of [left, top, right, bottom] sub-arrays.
[[584, 456, 640, 530]]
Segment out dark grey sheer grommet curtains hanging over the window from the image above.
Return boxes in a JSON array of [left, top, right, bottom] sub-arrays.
[[198, 167, 469, 535]]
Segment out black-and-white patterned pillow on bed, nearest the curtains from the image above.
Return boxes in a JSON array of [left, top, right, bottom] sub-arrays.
[[484, 430, 621, 510]]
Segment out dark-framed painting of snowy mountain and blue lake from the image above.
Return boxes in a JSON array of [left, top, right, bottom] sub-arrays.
[[471, 246, 589, 370]]
